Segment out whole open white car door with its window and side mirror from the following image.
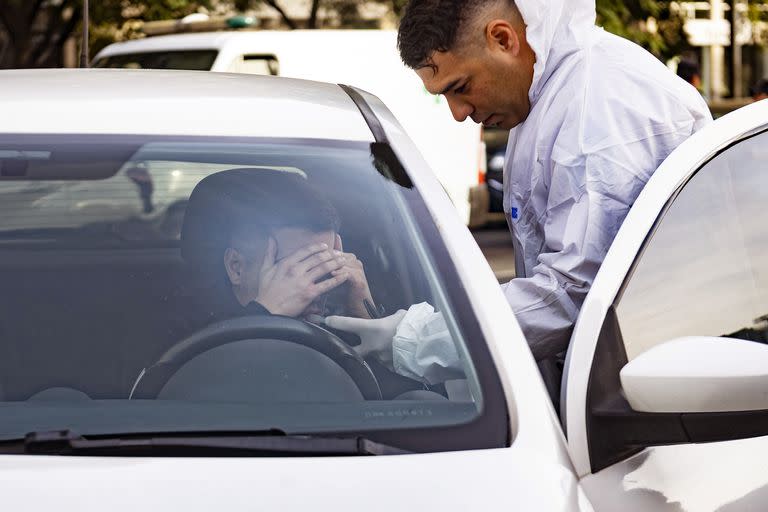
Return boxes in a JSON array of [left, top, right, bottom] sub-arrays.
[[562, 101, 768, 512]]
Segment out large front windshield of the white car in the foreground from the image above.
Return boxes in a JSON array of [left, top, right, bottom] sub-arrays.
[[0, 135, 506, 450]]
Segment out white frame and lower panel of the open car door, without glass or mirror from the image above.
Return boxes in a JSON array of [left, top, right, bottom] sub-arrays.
[[562, 101, 768, 511]]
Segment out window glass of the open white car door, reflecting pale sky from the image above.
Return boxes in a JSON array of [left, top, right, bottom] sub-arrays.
[[617, 128, 768, 360]]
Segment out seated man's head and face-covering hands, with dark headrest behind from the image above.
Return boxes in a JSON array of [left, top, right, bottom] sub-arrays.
[[174, 169, 372, 340]]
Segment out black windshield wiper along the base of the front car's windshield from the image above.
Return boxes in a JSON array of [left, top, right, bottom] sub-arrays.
[[0, 429, 410, 457]]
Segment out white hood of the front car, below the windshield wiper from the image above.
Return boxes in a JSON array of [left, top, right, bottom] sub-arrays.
[[0, 448, 585, 512]]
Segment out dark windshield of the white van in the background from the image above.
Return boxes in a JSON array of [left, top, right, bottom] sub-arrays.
[[93, 50, 218, 71]]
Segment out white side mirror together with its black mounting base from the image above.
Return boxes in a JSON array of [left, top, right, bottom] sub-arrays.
[[587, 332, 768, 473]]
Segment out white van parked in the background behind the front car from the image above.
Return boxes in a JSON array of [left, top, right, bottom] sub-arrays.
[[93, 30, 488, 227]]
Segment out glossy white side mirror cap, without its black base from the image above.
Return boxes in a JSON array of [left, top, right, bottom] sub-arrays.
[[619, 336, 768, 413]]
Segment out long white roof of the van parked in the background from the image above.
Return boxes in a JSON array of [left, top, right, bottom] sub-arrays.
[[94, 30, 397, 56]]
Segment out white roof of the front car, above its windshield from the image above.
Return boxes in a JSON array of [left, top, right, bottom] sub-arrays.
[[0, 69, 374, 142]]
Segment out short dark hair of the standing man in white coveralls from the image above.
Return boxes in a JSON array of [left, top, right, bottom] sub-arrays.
[[397, 0, 517, 69]]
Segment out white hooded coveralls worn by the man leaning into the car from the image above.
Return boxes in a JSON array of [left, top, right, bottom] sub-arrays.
[[332, 0, 712, 383]]
